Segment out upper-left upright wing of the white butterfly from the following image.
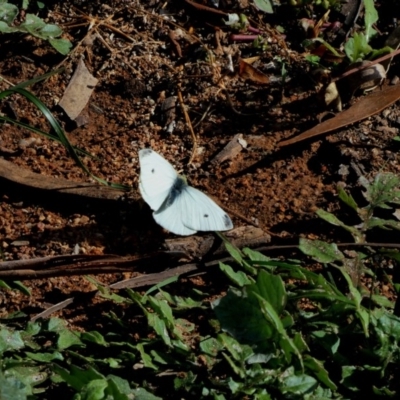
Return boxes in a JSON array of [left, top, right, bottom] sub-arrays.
[[139, 149, 178, 211]]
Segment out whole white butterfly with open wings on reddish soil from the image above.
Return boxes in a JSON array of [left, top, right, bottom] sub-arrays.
[[139, 149, 233, 236]]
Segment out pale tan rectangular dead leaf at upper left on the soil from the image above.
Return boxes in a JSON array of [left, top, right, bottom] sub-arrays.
[[59, 59, 98, 120]]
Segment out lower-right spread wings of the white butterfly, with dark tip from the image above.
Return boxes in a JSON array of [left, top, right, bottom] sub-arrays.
[[153, 184, 233, 236]]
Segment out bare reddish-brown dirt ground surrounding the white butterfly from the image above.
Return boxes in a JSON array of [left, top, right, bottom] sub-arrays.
[[0, 0, 400, 323]]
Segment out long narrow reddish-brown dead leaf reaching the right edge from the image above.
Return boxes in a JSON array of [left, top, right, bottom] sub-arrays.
[[277, 85, 400, 147]]
